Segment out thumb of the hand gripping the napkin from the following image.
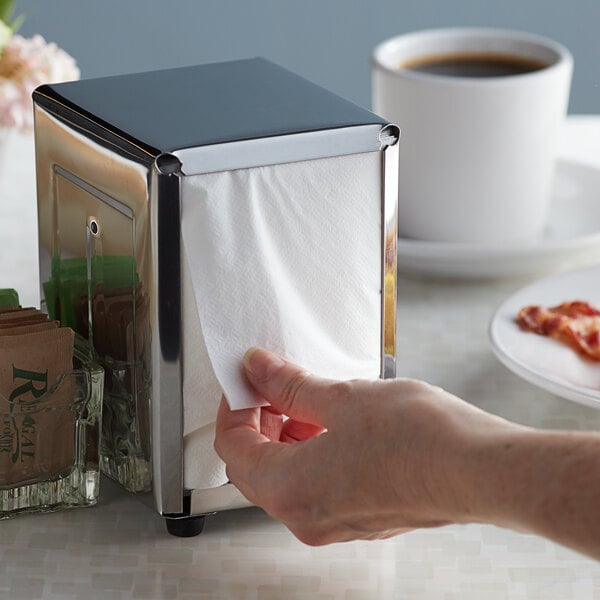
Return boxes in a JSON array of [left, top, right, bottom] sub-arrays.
[[244, 348, 337, 427]]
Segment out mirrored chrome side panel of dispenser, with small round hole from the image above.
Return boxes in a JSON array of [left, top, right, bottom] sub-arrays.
[[36, 107, 153, 492]]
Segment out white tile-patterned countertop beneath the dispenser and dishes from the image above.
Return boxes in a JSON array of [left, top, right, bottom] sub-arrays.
[[0, 117, 600, 600]]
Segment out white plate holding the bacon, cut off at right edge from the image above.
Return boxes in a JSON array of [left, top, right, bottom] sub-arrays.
[[489, 265, 600, 408]]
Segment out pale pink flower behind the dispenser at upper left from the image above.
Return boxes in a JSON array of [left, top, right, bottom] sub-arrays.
[[0, 35, 80, 129]]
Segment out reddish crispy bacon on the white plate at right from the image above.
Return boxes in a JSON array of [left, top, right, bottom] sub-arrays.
[[517, 300, 600, 361]]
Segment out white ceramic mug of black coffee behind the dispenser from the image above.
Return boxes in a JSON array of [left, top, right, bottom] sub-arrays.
[[372, 28, 573, 244]]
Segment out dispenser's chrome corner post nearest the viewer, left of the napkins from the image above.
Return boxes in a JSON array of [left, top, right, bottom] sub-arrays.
[[150, 154, 184, 516]]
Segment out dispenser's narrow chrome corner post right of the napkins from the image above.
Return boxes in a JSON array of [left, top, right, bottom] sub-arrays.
[[379, 124, 400, 379]]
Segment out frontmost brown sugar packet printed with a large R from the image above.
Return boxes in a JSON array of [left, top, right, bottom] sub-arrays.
[[0, 328, 75, 487]]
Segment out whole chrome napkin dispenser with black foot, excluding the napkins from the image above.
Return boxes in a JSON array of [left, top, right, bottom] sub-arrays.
[[33, 58, 399, 535]]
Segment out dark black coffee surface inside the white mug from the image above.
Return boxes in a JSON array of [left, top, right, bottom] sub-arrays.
[[400, 53, 548, 77]]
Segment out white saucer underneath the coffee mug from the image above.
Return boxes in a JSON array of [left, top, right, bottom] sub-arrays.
[[398, 160, 600, 278]]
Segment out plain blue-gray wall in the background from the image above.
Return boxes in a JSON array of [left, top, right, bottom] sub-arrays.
[[16, 0, 600, 113]]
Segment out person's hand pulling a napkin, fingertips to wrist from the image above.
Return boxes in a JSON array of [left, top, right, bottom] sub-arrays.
[[215, 349, 510, 545]]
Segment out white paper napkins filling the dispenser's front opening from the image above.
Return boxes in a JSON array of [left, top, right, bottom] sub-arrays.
[[182, 152, 382, 489]]
